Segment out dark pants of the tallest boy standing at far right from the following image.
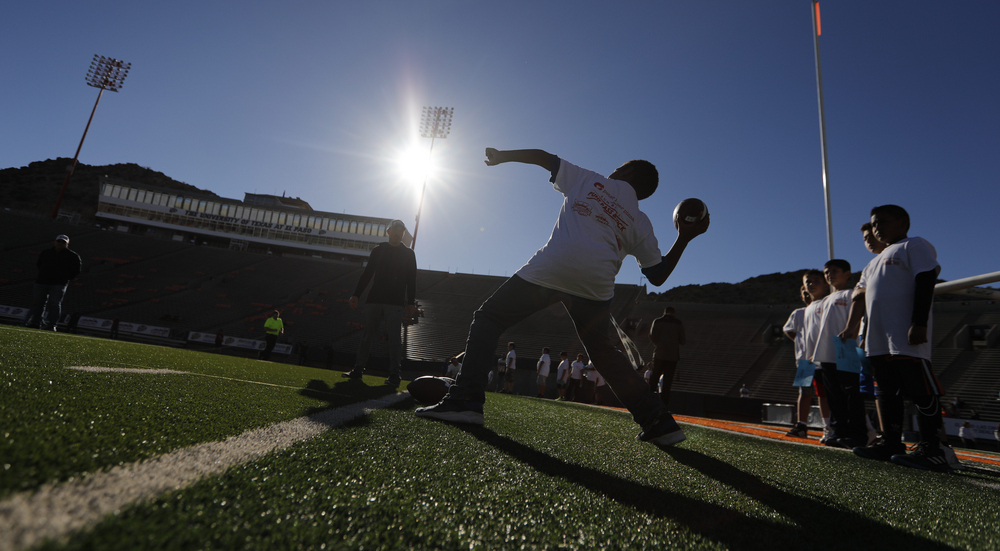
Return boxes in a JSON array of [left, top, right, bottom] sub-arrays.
[[869, 355, 943, 447]]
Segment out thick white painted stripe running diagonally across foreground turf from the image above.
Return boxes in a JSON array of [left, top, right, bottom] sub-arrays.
[[0, 392, 409, 550]]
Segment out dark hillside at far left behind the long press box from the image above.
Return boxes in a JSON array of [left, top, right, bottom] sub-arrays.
[[0, 157, 217, 221]]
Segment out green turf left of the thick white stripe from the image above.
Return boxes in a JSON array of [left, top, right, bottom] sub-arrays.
[[0, 326, 398, 498]]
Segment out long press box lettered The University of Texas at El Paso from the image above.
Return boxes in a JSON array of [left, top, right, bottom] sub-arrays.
[[96, 176, 412, 260]]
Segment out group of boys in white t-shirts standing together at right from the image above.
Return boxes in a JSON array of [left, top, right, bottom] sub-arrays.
[[784, 205, 958, 472]]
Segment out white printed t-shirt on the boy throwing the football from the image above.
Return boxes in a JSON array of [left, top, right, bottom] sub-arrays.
[[516, 160, 662, 301]]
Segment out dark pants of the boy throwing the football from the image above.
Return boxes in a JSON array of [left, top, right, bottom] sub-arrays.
[[448, 275, 666, 428]]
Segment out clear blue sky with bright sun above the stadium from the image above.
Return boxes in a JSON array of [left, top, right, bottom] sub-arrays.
[[0, 0, 1000, 296]]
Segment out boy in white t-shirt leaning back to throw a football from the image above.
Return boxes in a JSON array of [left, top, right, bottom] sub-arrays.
[[416, 148, 710, 445]]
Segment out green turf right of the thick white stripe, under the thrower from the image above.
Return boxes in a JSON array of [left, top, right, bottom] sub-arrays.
[[35, 395, 1000, 550]]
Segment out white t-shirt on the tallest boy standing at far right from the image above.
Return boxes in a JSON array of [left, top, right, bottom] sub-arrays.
[[858, 237, 941, 360]]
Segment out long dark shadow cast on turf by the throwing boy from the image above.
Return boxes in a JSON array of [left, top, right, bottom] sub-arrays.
[[456, 425, 947, 550]]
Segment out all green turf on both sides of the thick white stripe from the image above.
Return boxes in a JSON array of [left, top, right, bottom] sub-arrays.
[[7, 329, 1000, 551]]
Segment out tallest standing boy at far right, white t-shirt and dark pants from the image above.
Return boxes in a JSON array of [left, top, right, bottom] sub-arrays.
[[845, 205, 951, 472]]
